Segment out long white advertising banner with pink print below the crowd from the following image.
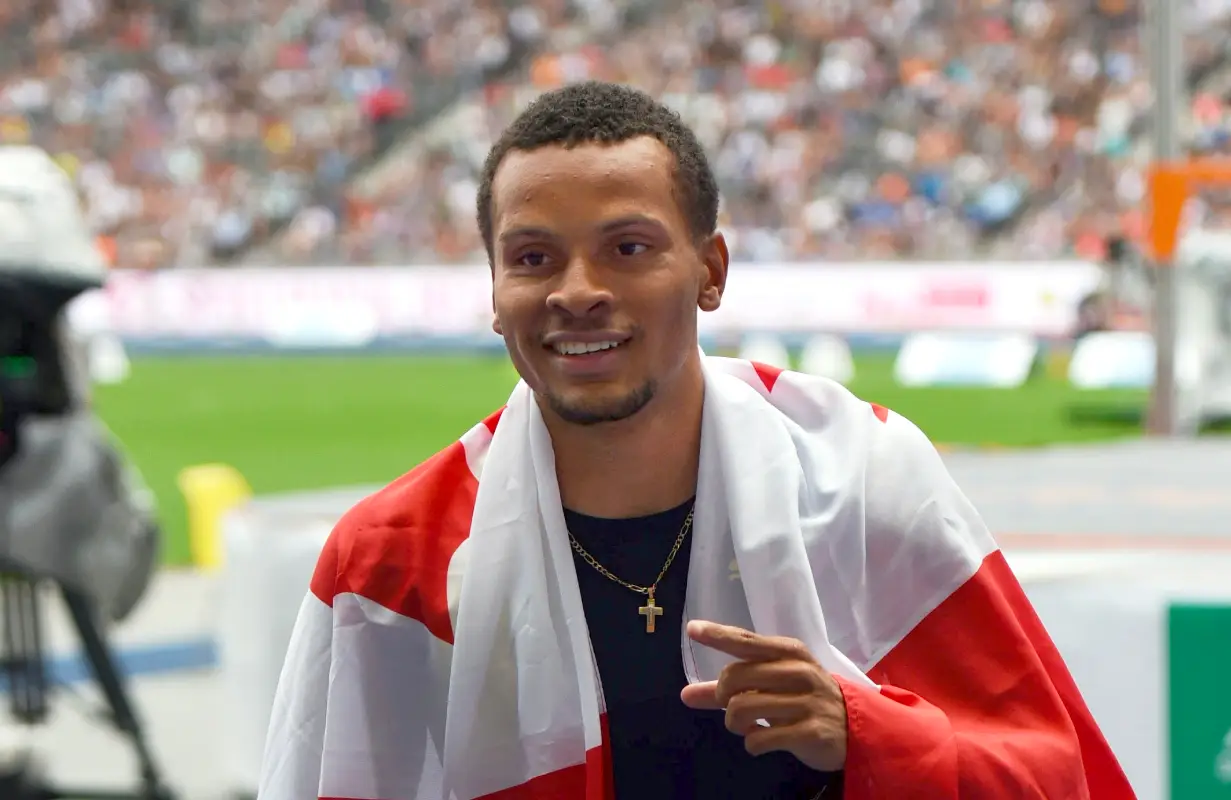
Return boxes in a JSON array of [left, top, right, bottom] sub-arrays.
[[71, 262, 1101, 346]]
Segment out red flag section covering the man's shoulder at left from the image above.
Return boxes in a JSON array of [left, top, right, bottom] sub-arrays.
[[311, 411, 500, 640]]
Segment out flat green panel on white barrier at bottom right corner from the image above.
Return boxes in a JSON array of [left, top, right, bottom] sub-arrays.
[[1167, 604, 1231, 800]]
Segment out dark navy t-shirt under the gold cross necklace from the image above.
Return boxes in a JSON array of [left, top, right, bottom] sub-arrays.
[[565, 501, 842, 800]]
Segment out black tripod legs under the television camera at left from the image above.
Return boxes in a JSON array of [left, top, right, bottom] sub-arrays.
[[0, 565, 174, 800]]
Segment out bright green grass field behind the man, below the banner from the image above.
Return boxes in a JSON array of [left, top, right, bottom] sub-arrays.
[[89, 356, 1144, 564]]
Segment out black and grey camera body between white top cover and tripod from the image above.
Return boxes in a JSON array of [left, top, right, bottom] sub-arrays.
[[0, 274, 161, 620]]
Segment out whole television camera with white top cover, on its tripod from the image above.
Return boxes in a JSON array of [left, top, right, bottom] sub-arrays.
[[0, 146, 171, 800]]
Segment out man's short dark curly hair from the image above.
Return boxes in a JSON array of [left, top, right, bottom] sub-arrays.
[[478, 81, 719, 262]]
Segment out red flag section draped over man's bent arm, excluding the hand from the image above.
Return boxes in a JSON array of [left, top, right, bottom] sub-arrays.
[[840, 551, 1135, 800]]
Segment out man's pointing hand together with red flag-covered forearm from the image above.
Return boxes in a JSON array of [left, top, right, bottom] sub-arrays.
[[681, 553, 1134, 800]]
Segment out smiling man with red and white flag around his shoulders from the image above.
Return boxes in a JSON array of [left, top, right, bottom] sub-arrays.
[[261, 82, 1133, 800]]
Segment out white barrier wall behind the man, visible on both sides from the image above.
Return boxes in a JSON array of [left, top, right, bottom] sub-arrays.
[[217, 489, 1231, 800]]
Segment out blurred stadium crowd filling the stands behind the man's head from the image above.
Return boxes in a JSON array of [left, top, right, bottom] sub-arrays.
[[7, 0, 1231, 268]]
